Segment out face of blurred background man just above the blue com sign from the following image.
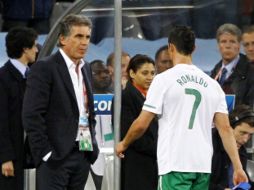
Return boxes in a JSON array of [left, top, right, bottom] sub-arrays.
[[91, 63, 111, 93]]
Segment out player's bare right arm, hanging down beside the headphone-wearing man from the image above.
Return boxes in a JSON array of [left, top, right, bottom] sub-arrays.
[[214, 113, 248, 185]]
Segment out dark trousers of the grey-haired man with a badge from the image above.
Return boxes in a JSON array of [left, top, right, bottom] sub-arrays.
[[36, 148, 90, 190]]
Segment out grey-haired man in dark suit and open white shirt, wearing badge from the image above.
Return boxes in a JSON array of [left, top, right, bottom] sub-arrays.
[[23, 15, 98, 190]]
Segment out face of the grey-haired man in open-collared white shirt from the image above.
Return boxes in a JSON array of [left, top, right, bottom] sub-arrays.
[[60, 26, 91, 63]]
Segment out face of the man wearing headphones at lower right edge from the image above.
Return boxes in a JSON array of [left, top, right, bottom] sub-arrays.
[[234, 122, 254, 149]]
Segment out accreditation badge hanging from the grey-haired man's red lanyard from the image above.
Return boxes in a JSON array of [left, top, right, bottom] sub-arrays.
[[78, 115, 93, 151]]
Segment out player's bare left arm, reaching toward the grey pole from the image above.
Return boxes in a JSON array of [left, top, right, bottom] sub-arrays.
[[116, 110, 155, 158]]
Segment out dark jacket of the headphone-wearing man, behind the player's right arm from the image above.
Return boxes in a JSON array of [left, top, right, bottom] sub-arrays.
[[209, 129, 254, 190]]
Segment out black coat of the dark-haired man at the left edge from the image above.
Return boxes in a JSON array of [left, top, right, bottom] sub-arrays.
[[0, 61, 26, 190]]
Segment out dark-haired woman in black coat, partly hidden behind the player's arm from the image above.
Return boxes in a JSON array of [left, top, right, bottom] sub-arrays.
[[120, 54, 158, 190]]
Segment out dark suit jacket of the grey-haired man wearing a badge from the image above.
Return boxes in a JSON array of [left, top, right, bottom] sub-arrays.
[[23, 51, 98, 165]]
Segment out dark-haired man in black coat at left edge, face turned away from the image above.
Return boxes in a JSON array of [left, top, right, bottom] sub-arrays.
[[0, 27, 38, 190]]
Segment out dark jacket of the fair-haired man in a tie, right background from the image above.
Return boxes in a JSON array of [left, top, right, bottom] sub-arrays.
[[211, 54, 254, 106]]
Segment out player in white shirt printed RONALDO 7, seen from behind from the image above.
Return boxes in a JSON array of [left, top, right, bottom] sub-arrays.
[[116, 26, 247, 190]]
